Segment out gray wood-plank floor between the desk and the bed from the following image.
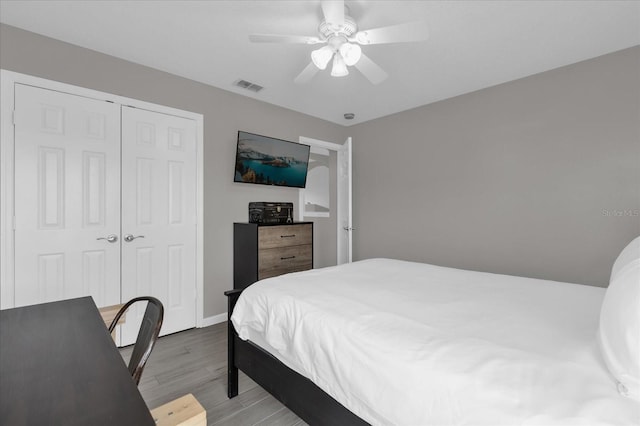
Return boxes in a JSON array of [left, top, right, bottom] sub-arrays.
[[120, 322, 306, 426]]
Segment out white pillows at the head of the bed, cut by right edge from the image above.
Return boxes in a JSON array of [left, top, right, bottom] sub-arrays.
[[598, 237, 640, 401]]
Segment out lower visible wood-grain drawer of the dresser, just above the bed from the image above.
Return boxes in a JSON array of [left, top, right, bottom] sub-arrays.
[[258, 244, 313, 280]]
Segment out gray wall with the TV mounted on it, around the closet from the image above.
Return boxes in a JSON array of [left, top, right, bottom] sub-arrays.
[[0, 25, 346, 317]]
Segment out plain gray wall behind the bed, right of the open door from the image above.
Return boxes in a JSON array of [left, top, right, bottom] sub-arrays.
[[350, 47, 640, 286]]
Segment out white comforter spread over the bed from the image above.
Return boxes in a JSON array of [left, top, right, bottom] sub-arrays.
[[232, 259, 640, 425]]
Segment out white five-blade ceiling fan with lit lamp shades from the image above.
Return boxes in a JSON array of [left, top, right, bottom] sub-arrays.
[[249, 0, 428, 84]]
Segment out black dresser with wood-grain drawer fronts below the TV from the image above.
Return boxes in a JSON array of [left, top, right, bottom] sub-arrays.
[[233, 222, 313, 289]]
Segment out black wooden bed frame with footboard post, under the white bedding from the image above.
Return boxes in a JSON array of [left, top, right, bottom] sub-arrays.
[[224, 289, 368, 426]]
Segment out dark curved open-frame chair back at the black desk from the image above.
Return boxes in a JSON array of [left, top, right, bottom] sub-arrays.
[[109, 296, 164, 385]]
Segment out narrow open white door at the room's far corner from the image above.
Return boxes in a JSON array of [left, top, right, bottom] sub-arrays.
[[338, 137, 353, 265]]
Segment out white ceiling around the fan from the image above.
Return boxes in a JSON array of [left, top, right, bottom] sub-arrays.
[[0, 0, 640, 125]]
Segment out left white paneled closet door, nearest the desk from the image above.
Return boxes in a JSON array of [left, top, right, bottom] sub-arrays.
[[15, 84, 120, 306]]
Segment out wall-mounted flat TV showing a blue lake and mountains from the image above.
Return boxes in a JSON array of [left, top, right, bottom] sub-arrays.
[[234, 131, 310, 188]]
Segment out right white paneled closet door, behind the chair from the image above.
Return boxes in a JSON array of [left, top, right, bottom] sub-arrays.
[[121, 107, 196, 345]]
